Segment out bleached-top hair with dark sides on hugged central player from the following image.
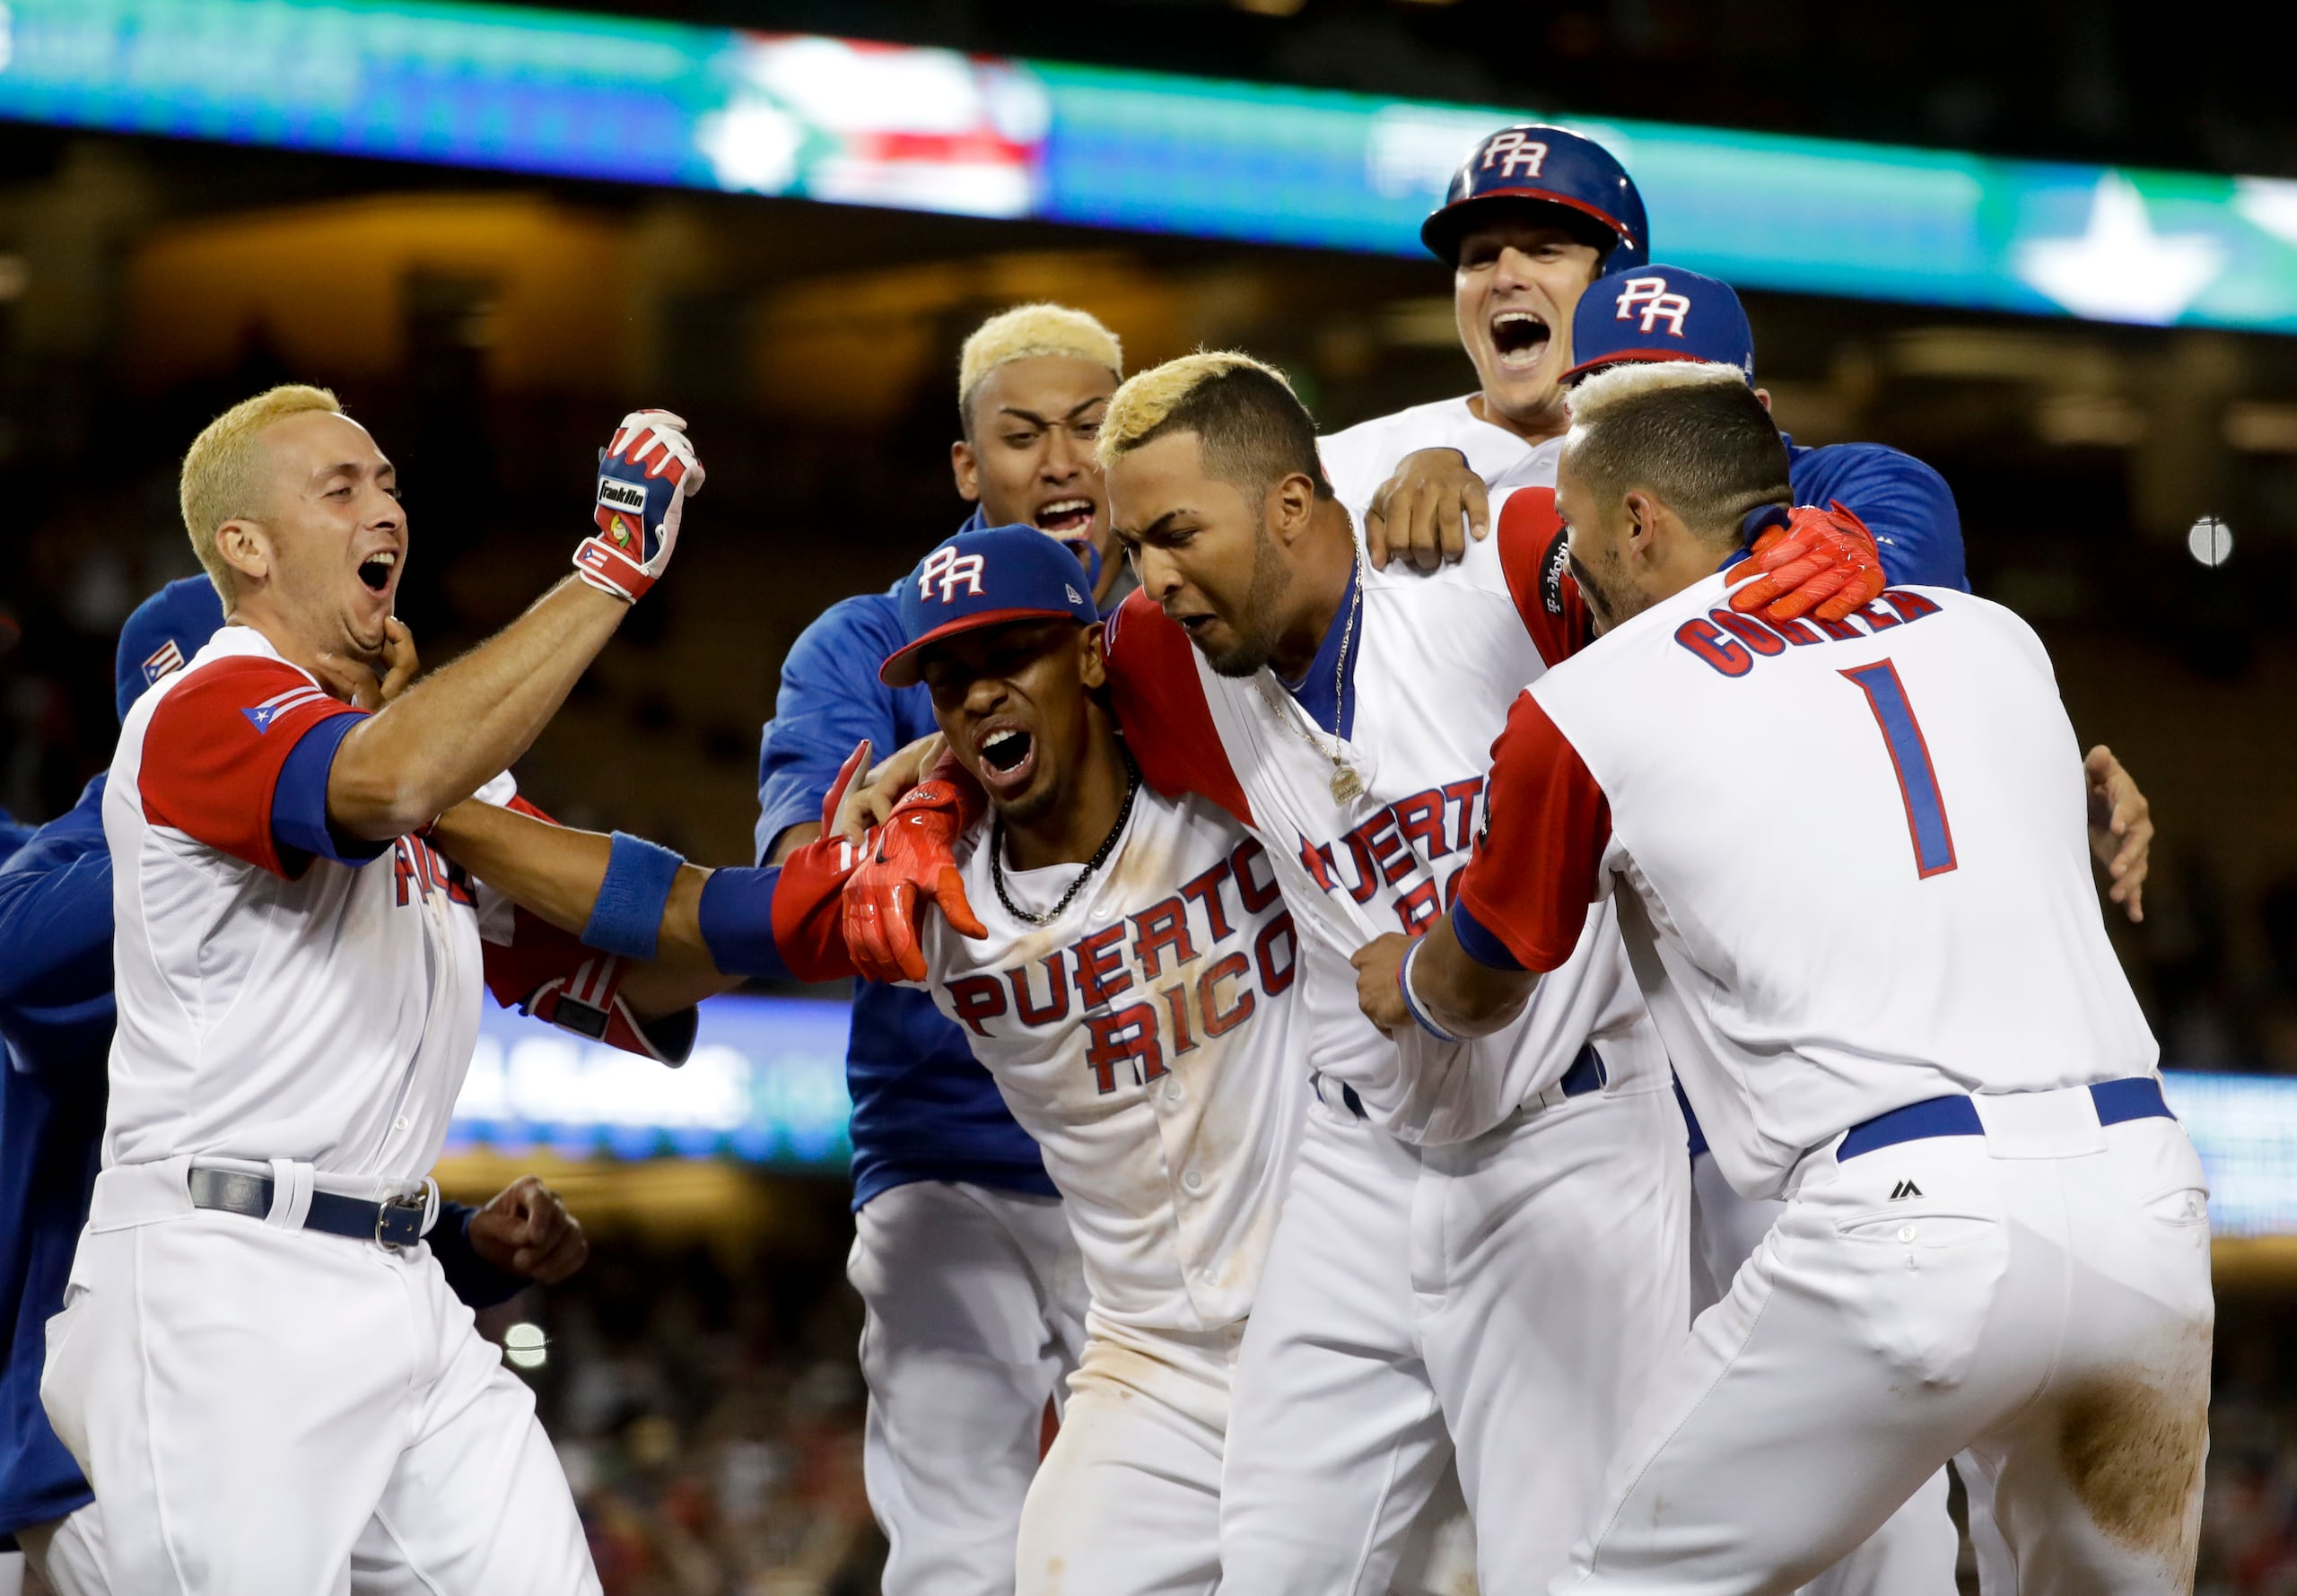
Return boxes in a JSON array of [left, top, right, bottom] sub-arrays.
[[1094, 349, 1332, 498]]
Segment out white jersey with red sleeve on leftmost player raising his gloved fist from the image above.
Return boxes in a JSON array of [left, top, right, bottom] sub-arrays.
[[103, 627, 633, 1191]]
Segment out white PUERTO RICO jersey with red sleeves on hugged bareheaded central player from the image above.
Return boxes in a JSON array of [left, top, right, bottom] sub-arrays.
[[1107, 489, 1665, 1144]]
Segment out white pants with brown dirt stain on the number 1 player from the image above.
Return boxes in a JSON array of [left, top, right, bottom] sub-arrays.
[[1553, 1088, 2214, 1596]]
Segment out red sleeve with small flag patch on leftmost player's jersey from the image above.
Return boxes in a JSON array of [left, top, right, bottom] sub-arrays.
[[135, 655, 365, 877]]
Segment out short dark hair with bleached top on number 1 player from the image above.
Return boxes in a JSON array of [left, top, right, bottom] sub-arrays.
[[1564, 361, 1792, 542]]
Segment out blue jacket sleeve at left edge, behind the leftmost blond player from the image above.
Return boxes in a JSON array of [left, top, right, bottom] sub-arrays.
[[0, 776, 112, 1075]]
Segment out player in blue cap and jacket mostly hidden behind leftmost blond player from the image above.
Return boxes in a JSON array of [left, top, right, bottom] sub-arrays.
[[0, 576, 590, 1596]]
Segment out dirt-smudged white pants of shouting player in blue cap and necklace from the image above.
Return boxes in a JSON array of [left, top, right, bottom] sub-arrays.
[[1016, 1313, 1245, 1596]]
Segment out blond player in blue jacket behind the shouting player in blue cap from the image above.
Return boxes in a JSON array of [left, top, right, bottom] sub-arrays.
[[755, 305, 1123, 1596]]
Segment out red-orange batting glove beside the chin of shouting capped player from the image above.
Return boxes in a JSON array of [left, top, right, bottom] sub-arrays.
[[845, 755, 990, 981]]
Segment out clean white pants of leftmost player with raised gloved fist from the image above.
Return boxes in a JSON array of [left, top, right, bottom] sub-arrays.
[[41, 1160, 598, 1596]]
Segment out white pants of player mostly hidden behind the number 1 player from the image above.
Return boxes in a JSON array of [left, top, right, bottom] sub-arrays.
[[1690, 1157, 1961, 1596]]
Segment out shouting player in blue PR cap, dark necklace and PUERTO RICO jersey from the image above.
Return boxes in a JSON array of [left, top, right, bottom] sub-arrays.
[[413, 526, 1307, 1596]]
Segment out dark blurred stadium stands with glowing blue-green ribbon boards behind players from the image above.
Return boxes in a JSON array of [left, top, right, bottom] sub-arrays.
[[0, 0, 2297, 1596]]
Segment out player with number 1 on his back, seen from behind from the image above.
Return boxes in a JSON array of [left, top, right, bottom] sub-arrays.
[[1368, 362, 2214, 1596]]
